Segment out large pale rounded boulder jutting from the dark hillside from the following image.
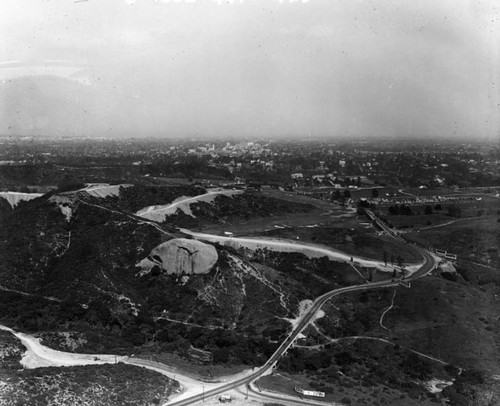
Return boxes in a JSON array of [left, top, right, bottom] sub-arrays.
[[137, 238, 219, 275]]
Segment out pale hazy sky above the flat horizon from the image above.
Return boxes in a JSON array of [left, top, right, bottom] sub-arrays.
[[0, 0, 500, 139]]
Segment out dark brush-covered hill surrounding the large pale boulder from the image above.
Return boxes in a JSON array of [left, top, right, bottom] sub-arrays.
[[0, 186, 362, 364]]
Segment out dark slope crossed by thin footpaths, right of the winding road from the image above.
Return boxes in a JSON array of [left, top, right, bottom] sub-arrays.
[[268, 276, 500, 406]]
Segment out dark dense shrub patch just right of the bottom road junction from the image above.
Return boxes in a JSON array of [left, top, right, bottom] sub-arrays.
[[278, 340, 450, 404]]
